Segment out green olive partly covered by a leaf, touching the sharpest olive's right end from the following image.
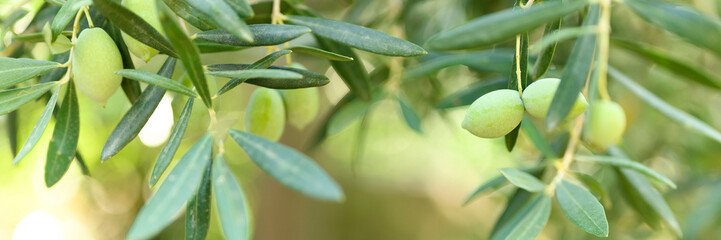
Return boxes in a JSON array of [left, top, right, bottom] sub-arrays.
[[522, 78, 588, 119]]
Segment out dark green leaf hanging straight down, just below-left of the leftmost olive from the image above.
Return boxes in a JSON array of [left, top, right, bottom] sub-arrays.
[[45, 82, 80, 188]]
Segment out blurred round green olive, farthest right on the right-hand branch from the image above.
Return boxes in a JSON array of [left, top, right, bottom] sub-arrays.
[[586, 100, 626, 149]]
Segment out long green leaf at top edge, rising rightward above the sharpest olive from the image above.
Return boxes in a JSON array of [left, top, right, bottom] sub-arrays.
[[425, 0, 588, 51]]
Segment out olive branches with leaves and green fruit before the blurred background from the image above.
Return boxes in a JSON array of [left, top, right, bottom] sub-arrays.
[[0, 0, 721, 239]]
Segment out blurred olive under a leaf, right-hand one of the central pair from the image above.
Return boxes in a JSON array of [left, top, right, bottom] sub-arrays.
[[280, 88, 318, 129]]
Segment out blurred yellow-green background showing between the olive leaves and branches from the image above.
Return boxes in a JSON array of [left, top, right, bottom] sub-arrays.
[[0, 0, 721, 240]]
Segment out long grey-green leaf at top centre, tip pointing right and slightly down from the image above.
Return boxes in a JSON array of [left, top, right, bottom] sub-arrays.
[[285, 16, 427, 57]]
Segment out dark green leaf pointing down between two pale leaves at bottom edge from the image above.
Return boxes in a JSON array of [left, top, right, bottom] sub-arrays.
[[185, 161, 213, 240]]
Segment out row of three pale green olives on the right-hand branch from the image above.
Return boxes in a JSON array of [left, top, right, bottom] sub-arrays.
[[462, 78, 626, 148]]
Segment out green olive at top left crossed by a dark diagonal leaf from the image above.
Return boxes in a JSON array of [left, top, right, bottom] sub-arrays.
[[121, 0, 162, 62]]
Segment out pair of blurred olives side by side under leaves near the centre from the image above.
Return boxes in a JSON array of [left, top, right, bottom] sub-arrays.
[[245, 87, 318, 141]]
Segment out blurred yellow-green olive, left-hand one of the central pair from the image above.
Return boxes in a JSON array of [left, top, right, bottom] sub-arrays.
[[245, 88, 285, 141]]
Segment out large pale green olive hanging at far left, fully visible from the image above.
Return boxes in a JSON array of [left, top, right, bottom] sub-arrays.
[[72, 28, 123, 106]]
